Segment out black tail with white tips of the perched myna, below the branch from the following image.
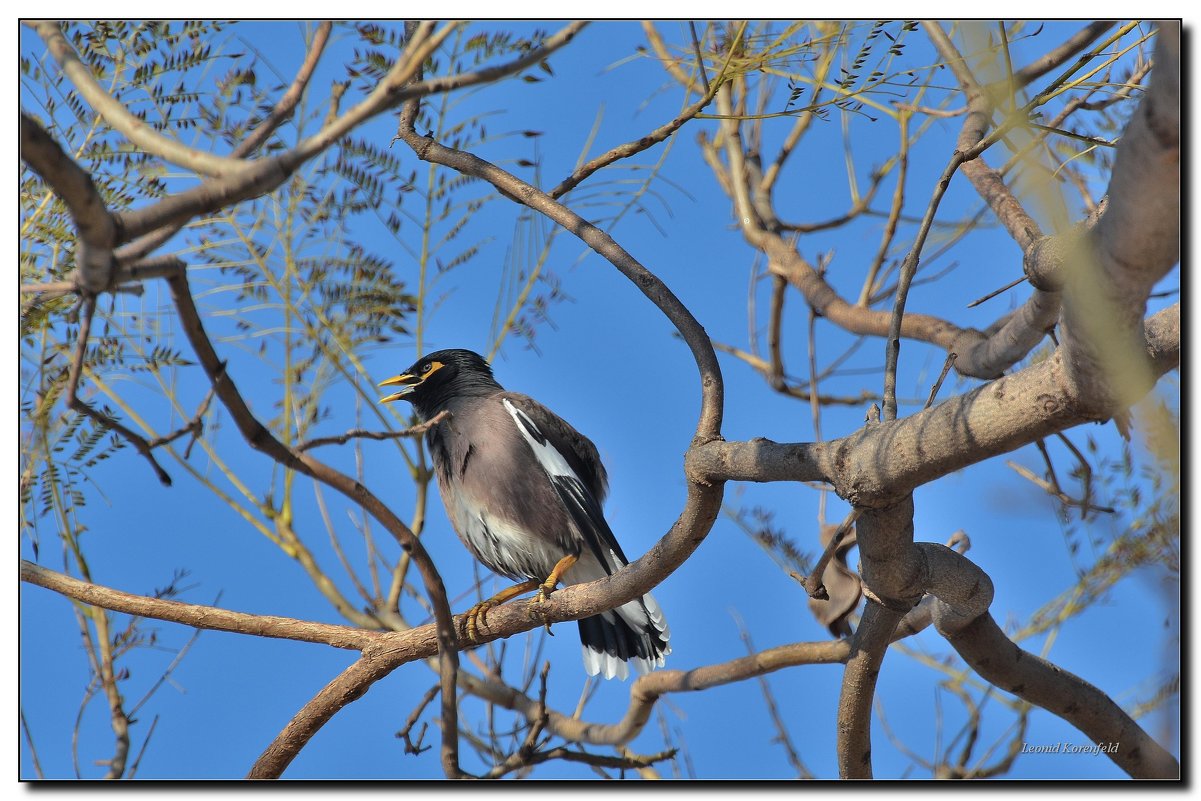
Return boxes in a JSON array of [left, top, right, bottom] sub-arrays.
[[579, 594, 671, 679]]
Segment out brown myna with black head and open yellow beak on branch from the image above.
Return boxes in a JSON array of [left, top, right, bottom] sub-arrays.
[[380, 348, 671, 680]]
